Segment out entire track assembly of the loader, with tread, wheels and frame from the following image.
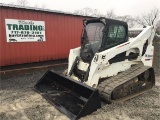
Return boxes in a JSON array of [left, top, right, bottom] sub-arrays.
[[97, 64, 155, 103]]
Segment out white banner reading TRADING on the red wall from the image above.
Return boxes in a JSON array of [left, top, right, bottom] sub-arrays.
[[5, 19, 46, 42]]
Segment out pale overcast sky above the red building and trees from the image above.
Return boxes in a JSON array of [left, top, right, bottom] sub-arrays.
[[0, 0, 160, 16]]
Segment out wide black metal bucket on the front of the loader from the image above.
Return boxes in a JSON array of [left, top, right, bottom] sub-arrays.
[[34, 71, 101, 119]]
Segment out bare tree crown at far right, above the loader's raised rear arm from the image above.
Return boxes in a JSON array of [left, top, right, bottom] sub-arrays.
[[136, 8, 160, 26]]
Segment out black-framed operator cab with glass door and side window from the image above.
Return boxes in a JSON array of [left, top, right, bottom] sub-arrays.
[[81, 18, 128, 62]]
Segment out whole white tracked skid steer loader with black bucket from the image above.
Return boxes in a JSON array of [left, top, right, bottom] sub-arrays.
[[35, 18, 155, 119]]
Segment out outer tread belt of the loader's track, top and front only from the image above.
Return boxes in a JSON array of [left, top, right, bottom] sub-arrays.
[[97, 64, 151, 103]]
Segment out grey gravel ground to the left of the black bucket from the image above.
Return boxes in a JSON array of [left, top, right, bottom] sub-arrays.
[[0, 68, 68, 120]]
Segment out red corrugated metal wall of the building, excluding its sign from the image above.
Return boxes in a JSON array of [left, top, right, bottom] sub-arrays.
[[0, 6, 89, 66]]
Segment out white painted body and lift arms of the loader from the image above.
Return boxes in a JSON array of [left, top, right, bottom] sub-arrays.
[[68, 26, 155, 88]]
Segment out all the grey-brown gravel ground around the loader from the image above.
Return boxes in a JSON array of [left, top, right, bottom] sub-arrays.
[[0, 67, 160, 120]]
